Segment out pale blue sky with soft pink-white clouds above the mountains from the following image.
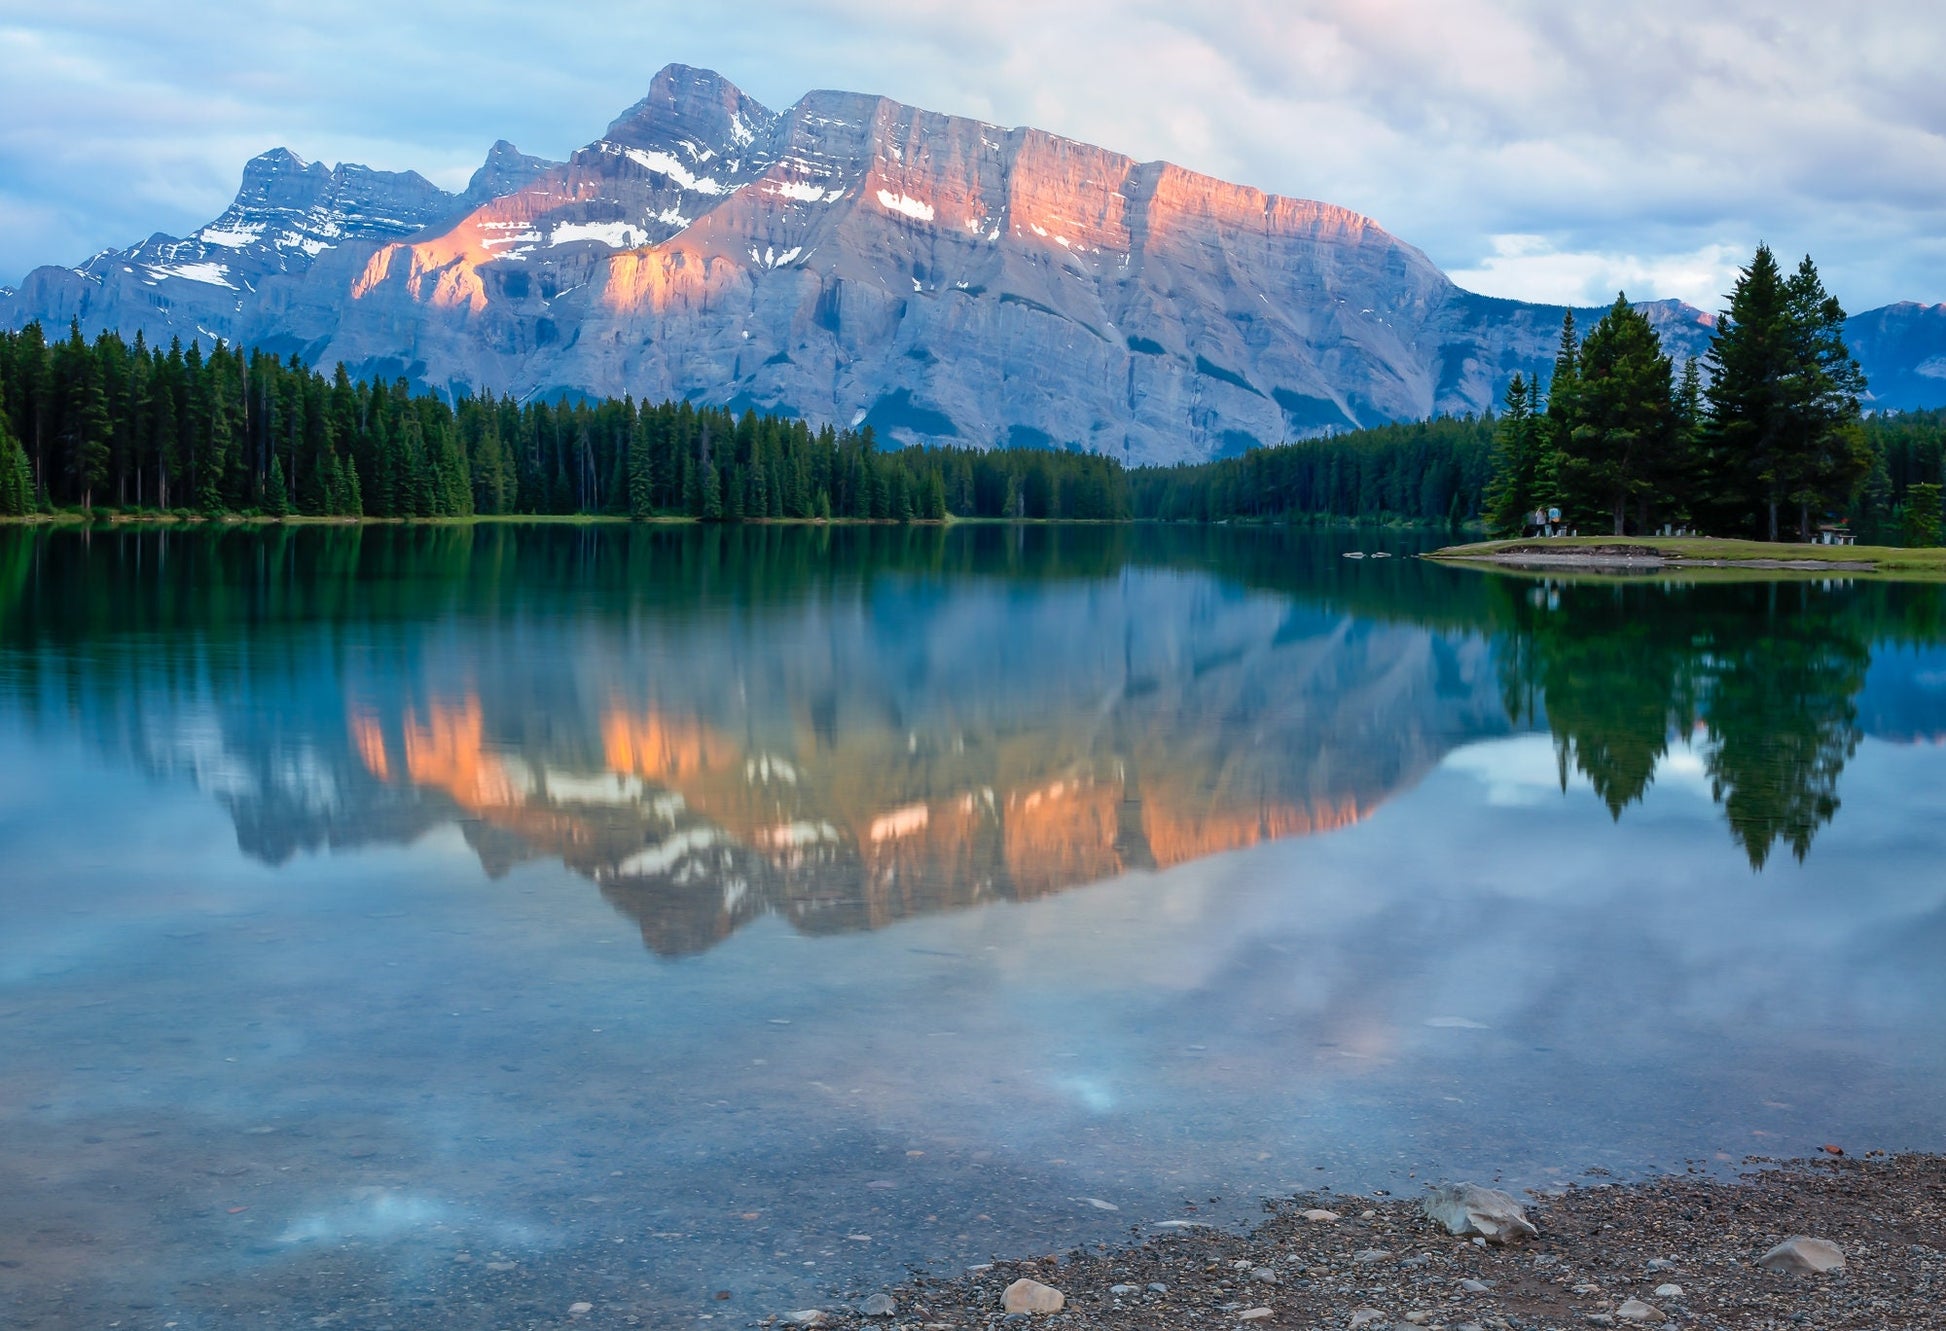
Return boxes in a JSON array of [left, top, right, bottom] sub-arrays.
[[0, 0, 1946, 311]]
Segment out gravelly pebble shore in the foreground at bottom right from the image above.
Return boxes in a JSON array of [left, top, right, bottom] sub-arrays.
[[793, 1152, 1946, 1331]]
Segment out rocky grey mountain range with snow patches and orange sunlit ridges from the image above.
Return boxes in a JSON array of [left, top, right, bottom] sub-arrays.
[[0, 64, 1946, 463]]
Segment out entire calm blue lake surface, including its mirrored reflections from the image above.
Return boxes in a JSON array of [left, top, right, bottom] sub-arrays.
[[0, 527, 1946, 1329]]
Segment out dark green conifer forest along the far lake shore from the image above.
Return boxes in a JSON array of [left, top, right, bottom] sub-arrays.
[[0, 247, 1946, 547]]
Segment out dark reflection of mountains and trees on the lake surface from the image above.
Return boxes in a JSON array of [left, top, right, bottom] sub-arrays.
[[0, 525, 1942, 955]]
